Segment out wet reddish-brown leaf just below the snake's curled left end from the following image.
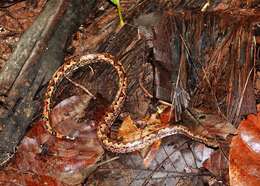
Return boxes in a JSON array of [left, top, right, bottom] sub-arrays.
[[14, 119, 104, 184]]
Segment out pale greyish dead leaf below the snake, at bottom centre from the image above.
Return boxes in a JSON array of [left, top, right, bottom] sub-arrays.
[[88, 142, 217, 186]]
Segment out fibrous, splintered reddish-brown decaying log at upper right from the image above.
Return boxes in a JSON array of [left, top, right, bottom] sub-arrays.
[[151, 11, 259, 123]]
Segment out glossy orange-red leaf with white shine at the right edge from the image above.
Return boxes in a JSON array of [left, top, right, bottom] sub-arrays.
[[229, 113, 260, 186]]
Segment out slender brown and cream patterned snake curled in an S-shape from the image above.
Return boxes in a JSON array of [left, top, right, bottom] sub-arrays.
[[42, 53, 219, 153]]
